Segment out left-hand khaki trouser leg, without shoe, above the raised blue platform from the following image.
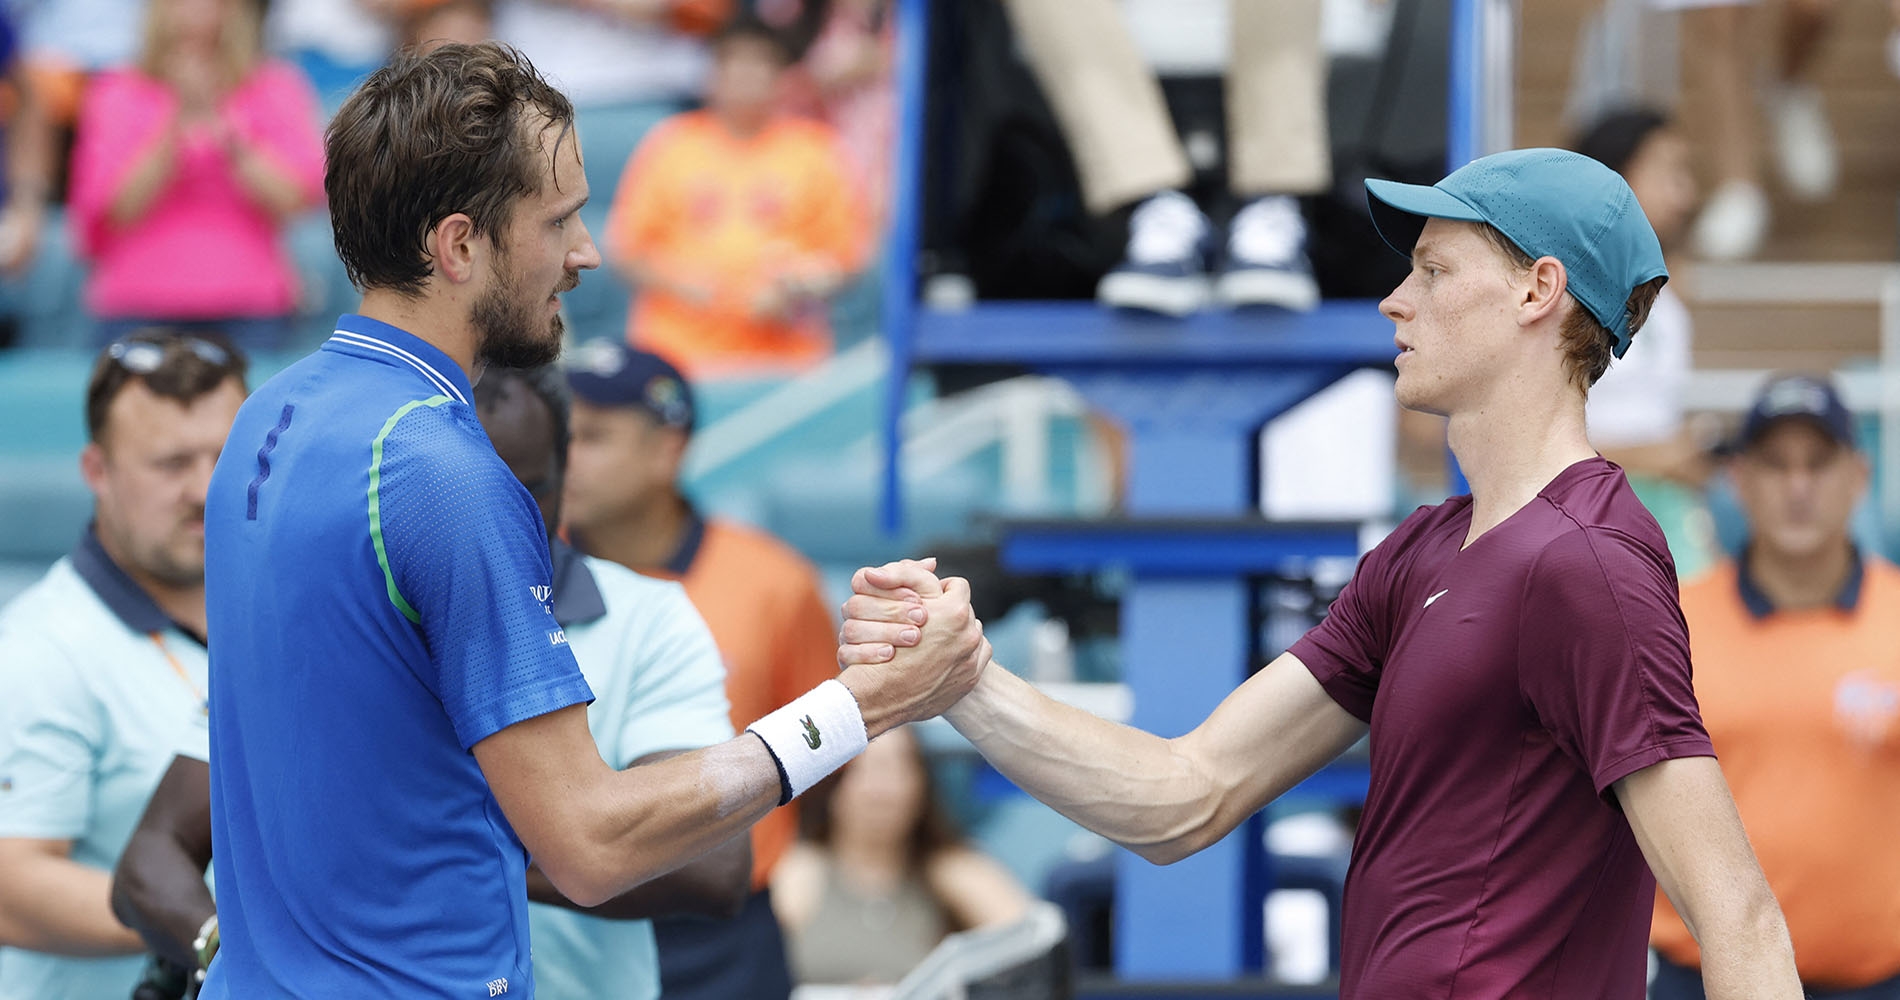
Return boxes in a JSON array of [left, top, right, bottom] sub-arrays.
[[1003, 0, 1193, 215]]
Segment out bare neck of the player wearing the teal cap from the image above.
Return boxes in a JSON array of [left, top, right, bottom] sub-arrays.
[[1446, 392, 1596, 546]]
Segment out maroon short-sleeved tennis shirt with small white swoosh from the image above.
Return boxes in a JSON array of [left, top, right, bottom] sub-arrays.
[[1292, 458, 1714, 1000]]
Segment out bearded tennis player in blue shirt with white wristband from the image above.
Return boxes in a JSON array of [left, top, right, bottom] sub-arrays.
[[203, 44, 988, 1000]]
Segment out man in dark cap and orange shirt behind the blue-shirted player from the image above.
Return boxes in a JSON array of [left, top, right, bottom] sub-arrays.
[[561, 342, 838, 1000]]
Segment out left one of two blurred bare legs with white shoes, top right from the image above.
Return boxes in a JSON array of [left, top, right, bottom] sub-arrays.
[[1682, 4, 1769, 260]]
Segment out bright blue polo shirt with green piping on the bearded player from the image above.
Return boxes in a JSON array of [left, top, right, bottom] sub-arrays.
[[203, 316, 593, 1000]]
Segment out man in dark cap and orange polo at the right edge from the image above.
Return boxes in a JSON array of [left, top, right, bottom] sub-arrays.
[[1651, 375, 1900, 1000]]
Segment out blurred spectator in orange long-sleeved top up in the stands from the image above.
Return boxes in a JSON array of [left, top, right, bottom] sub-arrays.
[[606, 15, 872, 378]]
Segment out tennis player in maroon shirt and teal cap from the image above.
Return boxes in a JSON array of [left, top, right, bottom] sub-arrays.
[[840, 150, 1801, 1000]]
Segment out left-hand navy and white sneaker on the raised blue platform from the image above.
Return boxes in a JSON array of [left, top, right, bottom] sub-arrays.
[[1094, 190, 1212, 316]]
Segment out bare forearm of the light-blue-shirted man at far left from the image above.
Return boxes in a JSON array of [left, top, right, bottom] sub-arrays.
[[0, 857, 144, 958]]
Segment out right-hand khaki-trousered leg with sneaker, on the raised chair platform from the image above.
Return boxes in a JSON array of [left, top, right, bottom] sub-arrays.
[[1216, 0, 1332, 310]]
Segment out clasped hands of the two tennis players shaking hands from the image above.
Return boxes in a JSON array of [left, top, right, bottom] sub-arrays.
[[838, 559, 990, 736]]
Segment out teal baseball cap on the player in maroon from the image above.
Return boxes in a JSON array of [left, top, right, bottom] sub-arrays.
[[1366, 148, 1668, 357]]
